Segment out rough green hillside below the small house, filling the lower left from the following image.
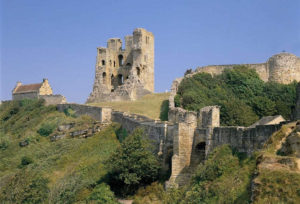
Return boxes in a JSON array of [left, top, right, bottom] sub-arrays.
[[0, 101, 119, 203]]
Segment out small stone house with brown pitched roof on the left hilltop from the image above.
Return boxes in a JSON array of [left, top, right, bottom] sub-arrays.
[[12, 79, 66, 105]]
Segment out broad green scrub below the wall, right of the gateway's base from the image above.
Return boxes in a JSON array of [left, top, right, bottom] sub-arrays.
[[184, 145, 255, 203]]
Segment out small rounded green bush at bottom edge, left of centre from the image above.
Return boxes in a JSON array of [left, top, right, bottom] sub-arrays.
[[87, 183, 118, 204]]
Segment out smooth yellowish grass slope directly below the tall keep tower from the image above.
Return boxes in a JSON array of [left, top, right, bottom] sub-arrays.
[[90, 93, 170, 120]]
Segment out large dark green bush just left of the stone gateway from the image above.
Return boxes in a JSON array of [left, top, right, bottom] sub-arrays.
[[106, 129, 159, 195]]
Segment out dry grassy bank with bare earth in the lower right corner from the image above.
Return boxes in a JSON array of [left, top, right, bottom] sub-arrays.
[[253, 122, 300, 204]]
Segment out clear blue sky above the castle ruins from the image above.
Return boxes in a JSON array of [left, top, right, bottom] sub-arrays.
[[0, 0, 300, 103]]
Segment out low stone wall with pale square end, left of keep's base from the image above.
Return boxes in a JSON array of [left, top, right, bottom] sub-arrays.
[[57, 103, 112, 123]]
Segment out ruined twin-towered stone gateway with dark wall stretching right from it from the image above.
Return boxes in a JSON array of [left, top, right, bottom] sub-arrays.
[[166, 103, 282, 187]]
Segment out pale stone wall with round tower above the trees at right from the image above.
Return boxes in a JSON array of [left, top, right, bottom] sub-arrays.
[[190, 53, 300, 84]]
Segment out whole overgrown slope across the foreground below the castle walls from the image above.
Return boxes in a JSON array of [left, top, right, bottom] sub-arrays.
[[0, 100, 300, 204]]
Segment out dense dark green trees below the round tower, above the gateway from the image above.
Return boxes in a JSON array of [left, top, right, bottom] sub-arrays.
[[174, 66, 297, 126]]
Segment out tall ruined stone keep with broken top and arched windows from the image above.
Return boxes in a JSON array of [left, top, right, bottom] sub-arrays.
[[87, 28, 154, 103]]
